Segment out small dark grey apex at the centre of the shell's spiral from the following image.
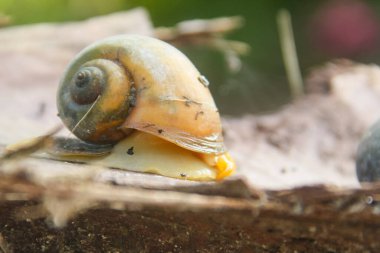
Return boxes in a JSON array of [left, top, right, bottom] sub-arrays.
[[70, 67, 106, 105]]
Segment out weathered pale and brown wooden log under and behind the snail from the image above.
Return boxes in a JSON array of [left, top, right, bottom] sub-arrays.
[[0, 9, 380, 252]]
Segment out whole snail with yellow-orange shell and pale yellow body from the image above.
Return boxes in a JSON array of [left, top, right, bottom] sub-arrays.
[[50, 35, 236, 180]]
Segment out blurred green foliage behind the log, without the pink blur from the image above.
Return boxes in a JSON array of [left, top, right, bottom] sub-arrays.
[[0, 0, 380, 114]]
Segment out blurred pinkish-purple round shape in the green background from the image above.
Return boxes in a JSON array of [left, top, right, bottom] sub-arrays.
[[311, 0, 380, 57]]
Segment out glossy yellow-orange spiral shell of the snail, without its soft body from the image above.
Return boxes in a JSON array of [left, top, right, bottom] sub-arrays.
[[57, 35, 225, 154]]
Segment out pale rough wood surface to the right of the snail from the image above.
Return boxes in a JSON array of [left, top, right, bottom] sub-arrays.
[[225, 62, 380, 189]]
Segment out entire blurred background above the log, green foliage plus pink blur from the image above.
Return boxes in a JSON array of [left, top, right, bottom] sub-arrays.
[[0, 0, 380, 115]]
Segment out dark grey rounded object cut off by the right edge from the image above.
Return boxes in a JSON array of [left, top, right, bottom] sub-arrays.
[[356, 121, 380, 182]]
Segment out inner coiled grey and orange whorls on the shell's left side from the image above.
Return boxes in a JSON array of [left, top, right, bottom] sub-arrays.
[[57, 50, 134, 144]]
